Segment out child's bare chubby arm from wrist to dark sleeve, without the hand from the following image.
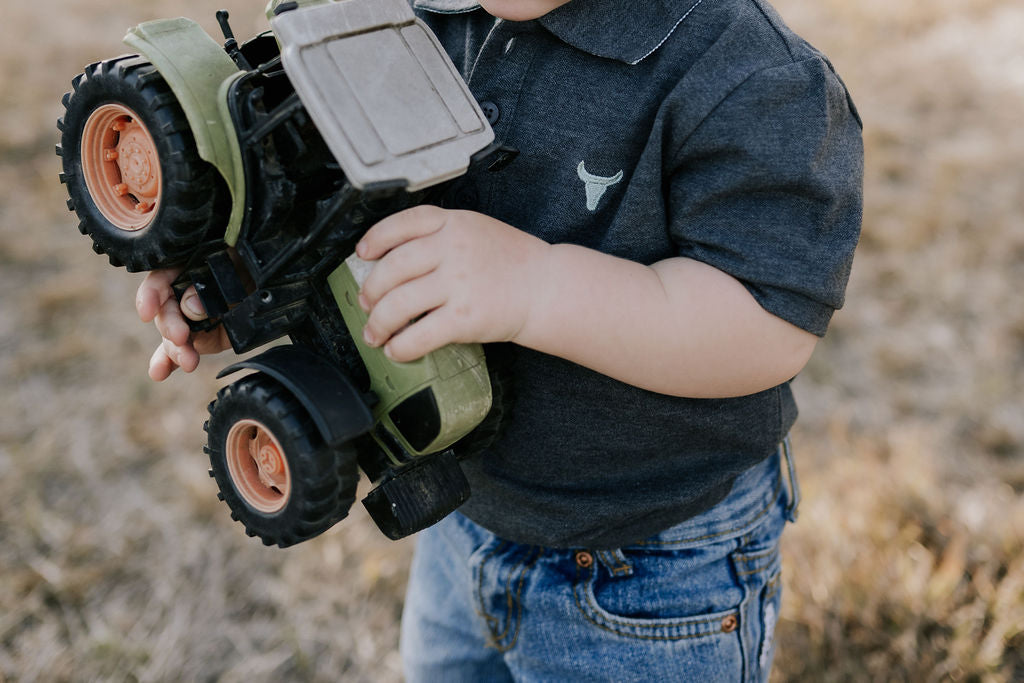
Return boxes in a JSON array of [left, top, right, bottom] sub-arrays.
[[515, 245, 817, 398]]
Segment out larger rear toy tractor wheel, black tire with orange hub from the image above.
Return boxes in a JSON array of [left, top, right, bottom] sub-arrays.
[[57, 55, 230, 272]]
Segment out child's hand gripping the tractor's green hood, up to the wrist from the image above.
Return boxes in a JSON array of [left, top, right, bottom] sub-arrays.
[[355, 206, 549, 361]]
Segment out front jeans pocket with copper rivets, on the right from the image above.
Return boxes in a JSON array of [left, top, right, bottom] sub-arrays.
[[572, 540, 743, 641]]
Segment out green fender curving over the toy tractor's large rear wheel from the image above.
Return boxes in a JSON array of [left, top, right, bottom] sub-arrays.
[[124, 17, 245, 234]]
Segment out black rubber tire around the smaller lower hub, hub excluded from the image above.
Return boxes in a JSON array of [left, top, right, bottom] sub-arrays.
[[206, 373, 359, 548]]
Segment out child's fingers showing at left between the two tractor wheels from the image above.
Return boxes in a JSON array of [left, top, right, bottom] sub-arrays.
[[135, 268, 230, 382]]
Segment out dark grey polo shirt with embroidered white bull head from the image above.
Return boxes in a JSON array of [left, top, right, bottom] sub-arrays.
[[413, 0, 863, 548]]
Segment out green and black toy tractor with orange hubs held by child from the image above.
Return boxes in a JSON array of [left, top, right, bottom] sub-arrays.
[[57, 0, 514, 547]]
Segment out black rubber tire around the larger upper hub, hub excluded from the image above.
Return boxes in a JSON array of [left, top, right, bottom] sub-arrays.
[[57, 55, 230, 272]]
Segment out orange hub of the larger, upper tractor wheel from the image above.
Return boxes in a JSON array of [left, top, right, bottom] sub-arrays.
[[82, 103, 162, 231]]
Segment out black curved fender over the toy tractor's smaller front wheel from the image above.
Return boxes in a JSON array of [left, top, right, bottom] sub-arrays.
[[217, 344, 374, 447]]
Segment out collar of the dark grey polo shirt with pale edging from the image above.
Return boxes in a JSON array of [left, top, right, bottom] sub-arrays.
[[414, 0, 705, 65]]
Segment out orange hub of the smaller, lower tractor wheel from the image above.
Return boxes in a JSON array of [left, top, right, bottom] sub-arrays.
[[224, 420, 292, 513]]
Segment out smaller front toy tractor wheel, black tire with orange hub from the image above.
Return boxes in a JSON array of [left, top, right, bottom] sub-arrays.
[[206, 373, 359, 548]]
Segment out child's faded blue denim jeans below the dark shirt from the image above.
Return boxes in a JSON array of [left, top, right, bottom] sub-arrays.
[[401, 442, 799, 683]]
